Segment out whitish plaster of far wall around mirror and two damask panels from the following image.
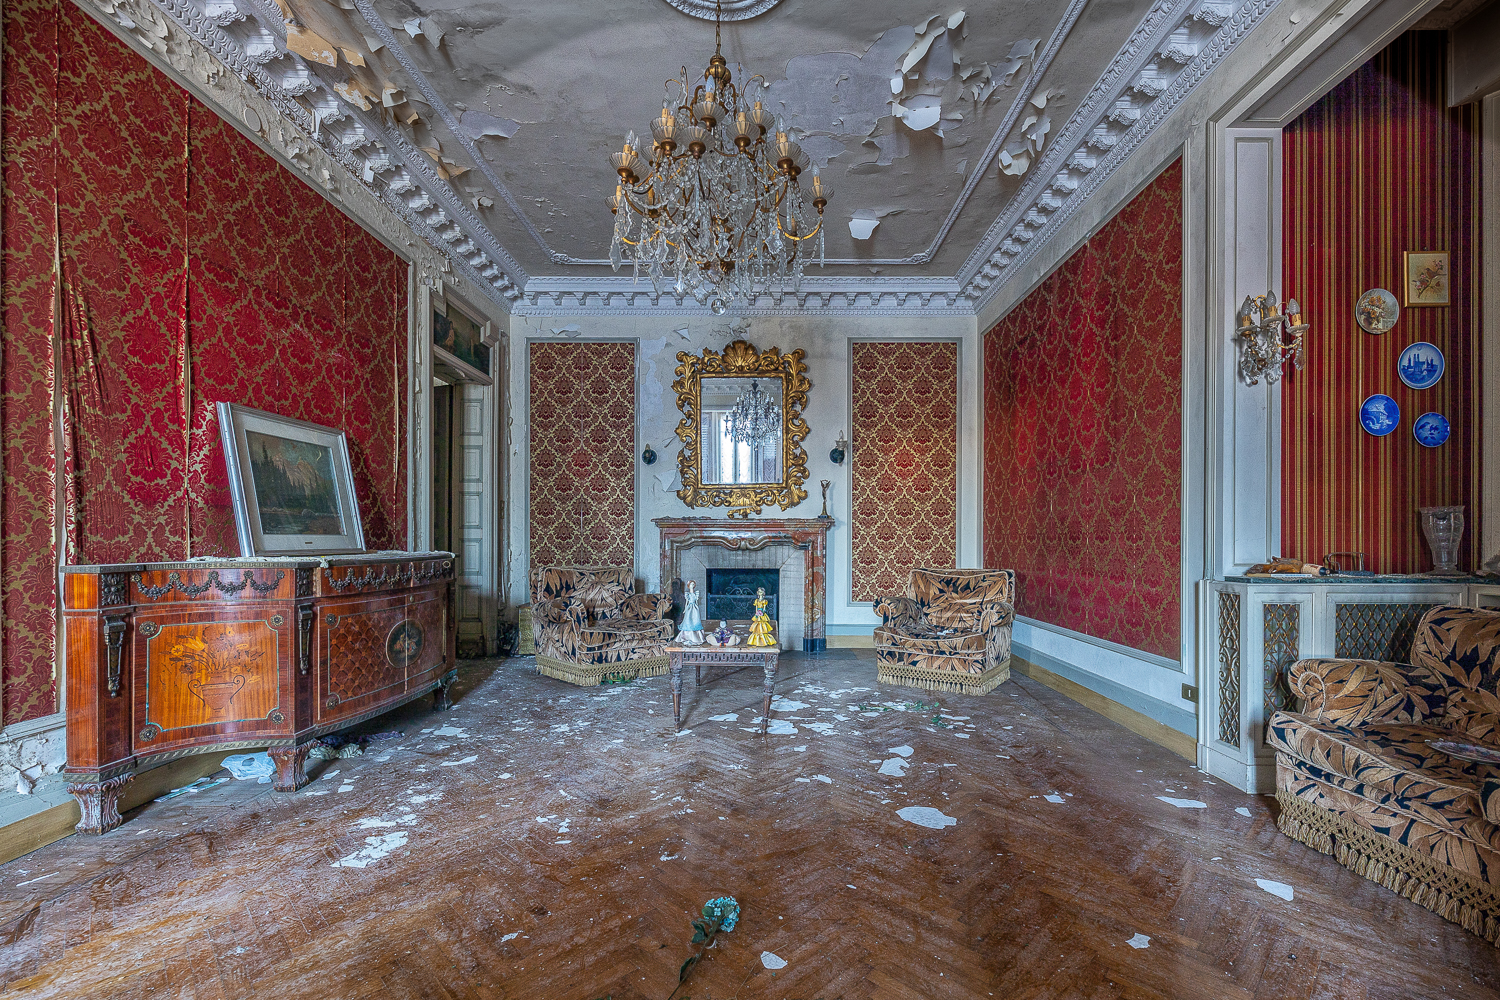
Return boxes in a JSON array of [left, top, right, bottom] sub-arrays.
[[506, 308, 981, 636]]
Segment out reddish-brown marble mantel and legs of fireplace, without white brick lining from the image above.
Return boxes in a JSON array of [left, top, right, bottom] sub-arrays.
[[651, 517, 834, 652]]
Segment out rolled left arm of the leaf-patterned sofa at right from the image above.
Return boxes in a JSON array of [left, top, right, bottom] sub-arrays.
[[1289, 660, 1448, 726]]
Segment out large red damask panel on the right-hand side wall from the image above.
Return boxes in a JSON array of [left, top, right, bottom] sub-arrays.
[[984, 160, 1182, 660]]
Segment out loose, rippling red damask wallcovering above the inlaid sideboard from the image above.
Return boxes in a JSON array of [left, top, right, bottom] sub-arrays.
[[0, 0, 407, 724]]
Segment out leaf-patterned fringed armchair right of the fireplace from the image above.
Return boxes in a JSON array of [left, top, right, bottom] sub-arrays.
[[875, 570, 1016, 694]]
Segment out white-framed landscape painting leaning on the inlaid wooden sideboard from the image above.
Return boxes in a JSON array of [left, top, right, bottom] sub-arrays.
[[216, 403, 365, 559]]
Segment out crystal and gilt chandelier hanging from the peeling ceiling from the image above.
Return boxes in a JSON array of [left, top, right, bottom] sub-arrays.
[[609, 4, 833, 315]]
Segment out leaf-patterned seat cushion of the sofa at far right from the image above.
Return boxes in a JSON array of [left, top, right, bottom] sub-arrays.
[[1266, 712, 1500, 841]]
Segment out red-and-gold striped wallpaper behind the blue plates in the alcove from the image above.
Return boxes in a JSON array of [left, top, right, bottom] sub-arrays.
[[1281, 31, 1476, 573]]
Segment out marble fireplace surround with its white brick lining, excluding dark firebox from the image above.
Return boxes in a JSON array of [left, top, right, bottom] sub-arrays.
[[653, 517, 834, 652]]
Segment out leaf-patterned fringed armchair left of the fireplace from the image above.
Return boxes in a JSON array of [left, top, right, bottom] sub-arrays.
[[531, 567, 674, 687]]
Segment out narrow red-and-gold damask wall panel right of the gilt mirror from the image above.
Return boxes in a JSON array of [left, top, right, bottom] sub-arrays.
[[851, 340, 959, 601]]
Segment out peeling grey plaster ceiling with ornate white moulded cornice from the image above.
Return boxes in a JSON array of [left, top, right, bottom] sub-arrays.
[[117, 0, 1272, 310]]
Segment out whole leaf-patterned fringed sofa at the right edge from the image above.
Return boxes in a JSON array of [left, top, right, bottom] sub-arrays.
[[1268, 606, 1500, 943]]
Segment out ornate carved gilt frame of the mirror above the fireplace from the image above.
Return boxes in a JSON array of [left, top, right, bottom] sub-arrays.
[[672, 340, 812, 517]]
